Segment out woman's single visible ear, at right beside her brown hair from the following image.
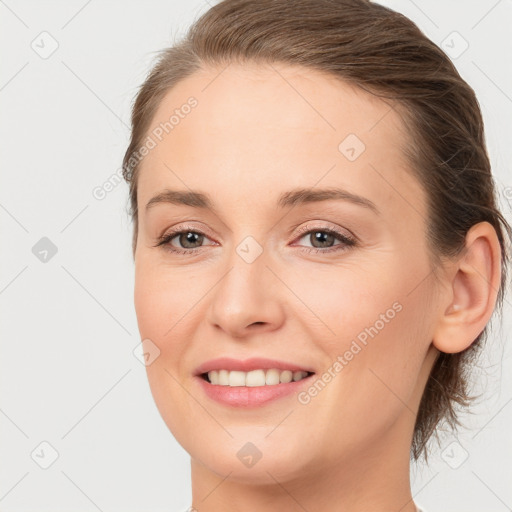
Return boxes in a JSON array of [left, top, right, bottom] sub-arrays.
[[433, 222, 501, 354]]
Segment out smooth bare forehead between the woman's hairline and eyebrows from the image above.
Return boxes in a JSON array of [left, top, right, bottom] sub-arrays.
[[138, 63, 419, 222]]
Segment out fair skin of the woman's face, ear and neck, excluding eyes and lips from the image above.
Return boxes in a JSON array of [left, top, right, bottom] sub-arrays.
[[131, 64, 500, 512]]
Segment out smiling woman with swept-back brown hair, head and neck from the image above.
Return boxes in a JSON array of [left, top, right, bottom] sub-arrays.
[[123, 0, 512, 512]]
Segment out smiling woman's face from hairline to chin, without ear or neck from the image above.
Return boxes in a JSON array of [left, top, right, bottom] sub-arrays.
[[135, 65, 439, 483]]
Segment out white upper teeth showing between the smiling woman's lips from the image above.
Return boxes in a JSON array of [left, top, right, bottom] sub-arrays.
[[208, 369, 308, 387]]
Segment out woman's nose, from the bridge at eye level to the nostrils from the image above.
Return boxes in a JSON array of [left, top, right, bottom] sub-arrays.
[[207, 248, 284, 339]]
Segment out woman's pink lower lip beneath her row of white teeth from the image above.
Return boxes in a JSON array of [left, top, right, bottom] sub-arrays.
[[196, 375, 313, 407]]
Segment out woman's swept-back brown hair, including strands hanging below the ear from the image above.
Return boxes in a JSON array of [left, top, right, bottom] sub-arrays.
[[123, 0, 512, 460]]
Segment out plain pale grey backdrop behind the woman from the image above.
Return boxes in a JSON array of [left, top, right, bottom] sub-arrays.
[[0, 0, 512, 512]]
